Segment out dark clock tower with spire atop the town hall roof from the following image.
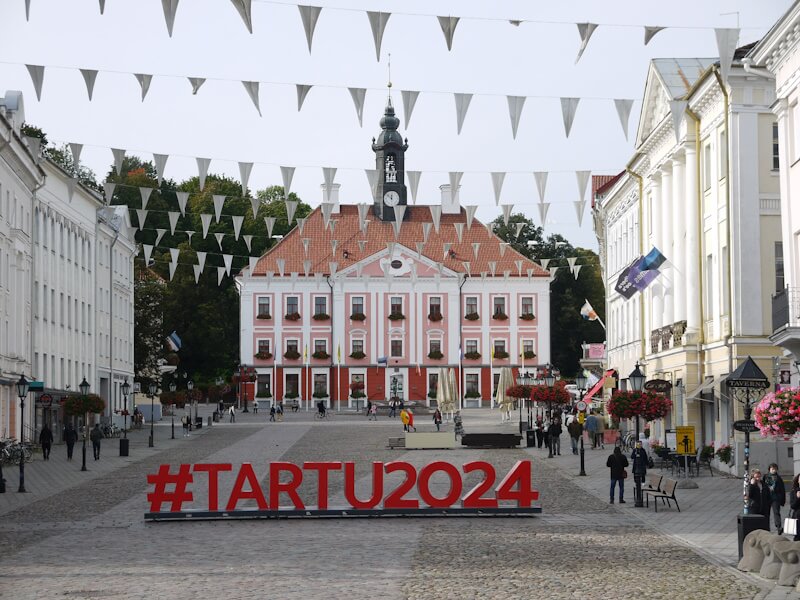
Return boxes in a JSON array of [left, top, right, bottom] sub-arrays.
[[372, 96, 409, 221]]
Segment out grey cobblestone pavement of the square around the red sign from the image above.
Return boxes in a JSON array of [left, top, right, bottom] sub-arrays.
[[0, 417, 780, 600]]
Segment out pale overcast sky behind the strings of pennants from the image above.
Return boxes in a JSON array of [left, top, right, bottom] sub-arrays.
[[0, 0, 791, 248]]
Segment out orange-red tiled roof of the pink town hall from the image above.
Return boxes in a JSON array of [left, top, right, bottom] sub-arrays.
[[252, 204, 550, 277]]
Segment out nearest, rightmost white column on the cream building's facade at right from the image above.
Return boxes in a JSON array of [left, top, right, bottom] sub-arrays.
[[683, 139, 702, 336]]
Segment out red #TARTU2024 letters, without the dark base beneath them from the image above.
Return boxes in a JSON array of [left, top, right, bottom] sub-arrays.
[[147, 460, 539, 513]]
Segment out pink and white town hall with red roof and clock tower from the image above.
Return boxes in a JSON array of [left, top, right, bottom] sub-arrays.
[[237, 101, 551, 408]]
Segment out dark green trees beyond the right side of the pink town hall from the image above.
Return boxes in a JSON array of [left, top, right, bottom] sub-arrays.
[[494, 213, 605, 377]]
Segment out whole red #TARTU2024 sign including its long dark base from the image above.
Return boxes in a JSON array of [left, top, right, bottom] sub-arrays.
[[145, 460, 541, 521]]
